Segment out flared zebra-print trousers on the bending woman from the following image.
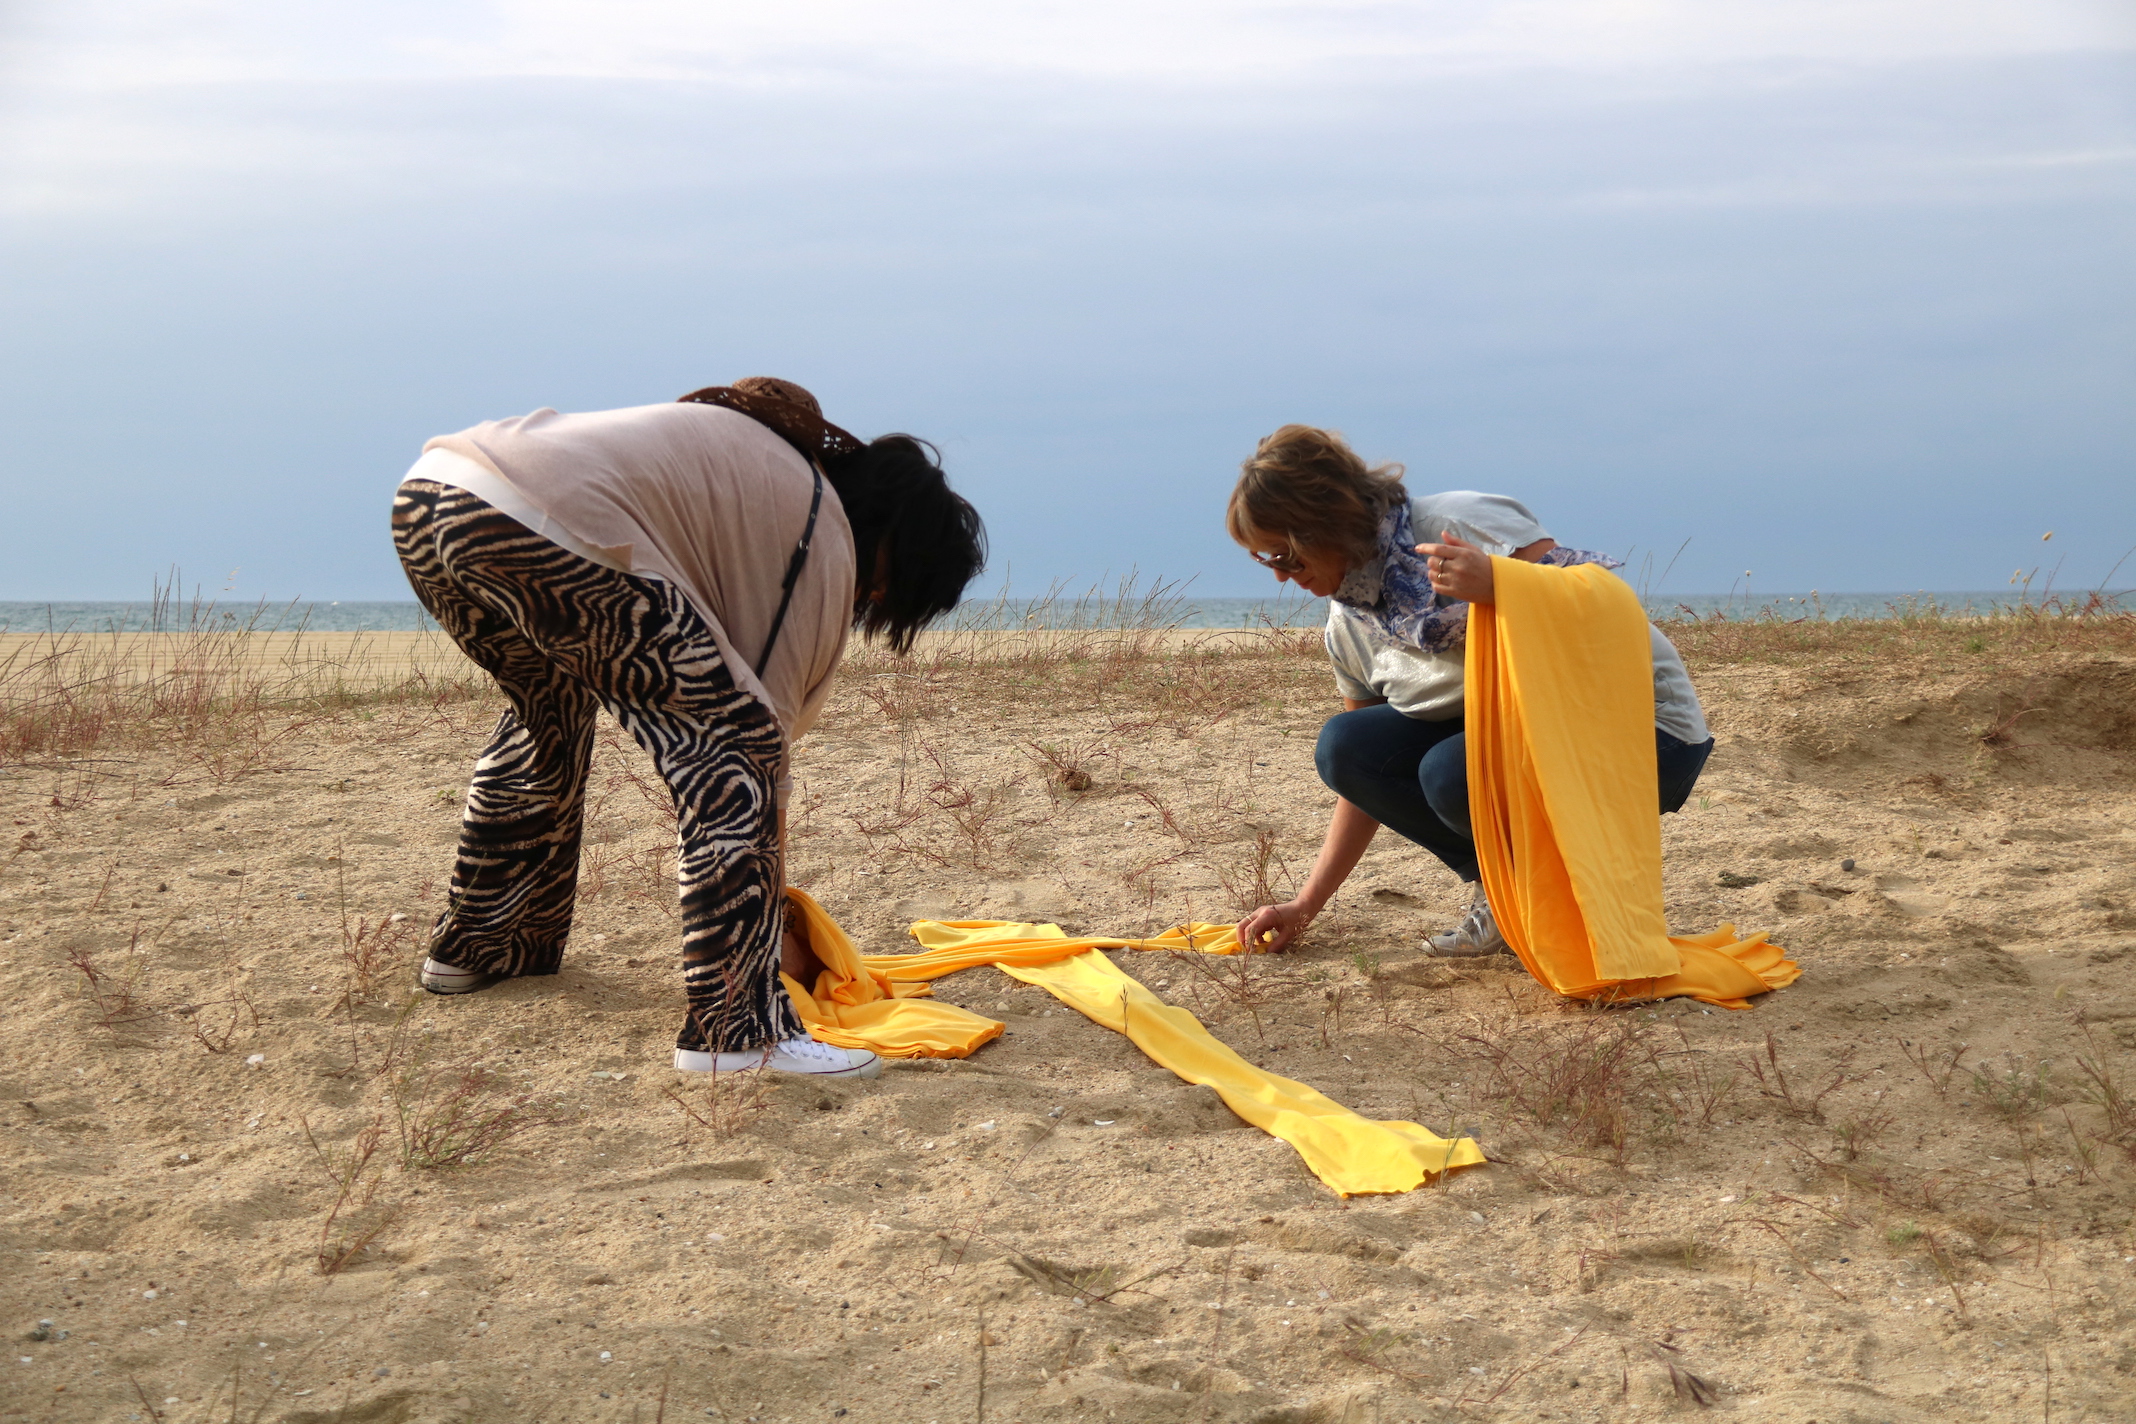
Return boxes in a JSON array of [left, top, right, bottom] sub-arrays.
[[393, 480, 805, 1053]]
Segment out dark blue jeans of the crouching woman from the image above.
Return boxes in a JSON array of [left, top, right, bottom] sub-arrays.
[[1314, 702, 1713, 882]]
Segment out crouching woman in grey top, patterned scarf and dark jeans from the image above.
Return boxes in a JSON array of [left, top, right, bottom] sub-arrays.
[[1226, 425, 1713, 956]]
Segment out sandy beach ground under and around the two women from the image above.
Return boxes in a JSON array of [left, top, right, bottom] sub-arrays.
[[0, 640, 2136, 1424]]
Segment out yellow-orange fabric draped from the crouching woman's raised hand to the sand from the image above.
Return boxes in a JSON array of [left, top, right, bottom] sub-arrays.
[[1465, 557, 1801, 1008]]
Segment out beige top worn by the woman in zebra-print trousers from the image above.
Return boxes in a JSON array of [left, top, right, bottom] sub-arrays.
[[408, 404, 854, 801]]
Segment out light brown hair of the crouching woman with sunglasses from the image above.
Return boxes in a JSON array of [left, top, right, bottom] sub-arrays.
[[1224, 425, 1410, 568]]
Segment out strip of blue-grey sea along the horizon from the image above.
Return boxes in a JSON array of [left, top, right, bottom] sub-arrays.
[[0, 589, 2136, 634]]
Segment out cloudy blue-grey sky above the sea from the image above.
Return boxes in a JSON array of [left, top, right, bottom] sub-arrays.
[[0, 0, 2136, 600]]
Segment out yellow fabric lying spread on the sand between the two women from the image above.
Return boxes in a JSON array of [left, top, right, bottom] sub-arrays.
[[786, 890, 1485, 1196]]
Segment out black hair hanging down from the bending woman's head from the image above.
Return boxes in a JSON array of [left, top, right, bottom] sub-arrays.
[[824, 436, 987, 653]]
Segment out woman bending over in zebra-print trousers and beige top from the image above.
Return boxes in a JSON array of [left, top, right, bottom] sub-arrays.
[[393, 376, 985, 1078]]
